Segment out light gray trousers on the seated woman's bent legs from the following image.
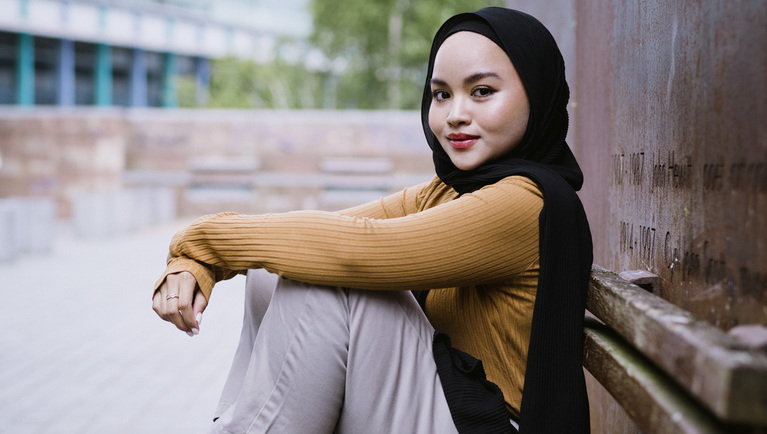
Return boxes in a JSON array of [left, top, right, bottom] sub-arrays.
[[210, 270, 457, 434]]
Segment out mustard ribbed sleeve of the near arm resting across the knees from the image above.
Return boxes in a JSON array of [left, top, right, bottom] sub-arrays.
[[158, 177, 542, 296]]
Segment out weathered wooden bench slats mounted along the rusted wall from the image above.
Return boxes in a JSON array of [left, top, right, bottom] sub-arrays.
[[583, 267, 767, 434]]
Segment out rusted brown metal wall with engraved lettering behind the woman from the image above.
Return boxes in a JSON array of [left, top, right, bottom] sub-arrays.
[[508, 0, 767, 433]]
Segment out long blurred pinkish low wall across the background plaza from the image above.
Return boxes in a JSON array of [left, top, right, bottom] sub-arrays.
[[0, 107, 433, 218]]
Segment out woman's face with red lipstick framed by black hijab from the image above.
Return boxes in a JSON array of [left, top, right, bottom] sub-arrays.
[[429, 31, 530, 170]]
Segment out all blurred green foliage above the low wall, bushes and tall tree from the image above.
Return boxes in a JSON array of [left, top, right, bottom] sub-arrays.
[[192, 0, 505, 109]]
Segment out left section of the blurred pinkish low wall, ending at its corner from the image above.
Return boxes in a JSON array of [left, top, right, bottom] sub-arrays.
[[0, 108, 127, 217]]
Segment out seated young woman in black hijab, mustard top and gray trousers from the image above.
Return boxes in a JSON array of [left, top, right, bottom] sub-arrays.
[[153, 8, 592, 433]]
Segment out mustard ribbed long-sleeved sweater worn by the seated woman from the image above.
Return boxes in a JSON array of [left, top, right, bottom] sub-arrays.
[[155, 176, 543, 417]]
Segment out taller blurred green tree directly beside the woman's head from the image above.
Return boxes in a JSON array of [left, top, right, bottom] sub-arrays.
[[310, 0, 505, 109]]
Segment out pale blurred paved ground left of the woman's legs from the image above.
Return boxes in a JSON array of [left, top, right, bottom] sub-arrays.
[[0, 223, 245, 434]]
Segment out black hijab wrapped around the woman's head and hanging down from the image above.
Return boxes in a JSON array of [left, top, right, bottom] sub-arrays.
[[421, 8, 592, 434]]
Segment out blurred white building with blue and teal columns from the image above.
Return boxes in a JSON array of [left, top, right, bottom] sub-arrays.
[[0, 0, 311, 107]]
